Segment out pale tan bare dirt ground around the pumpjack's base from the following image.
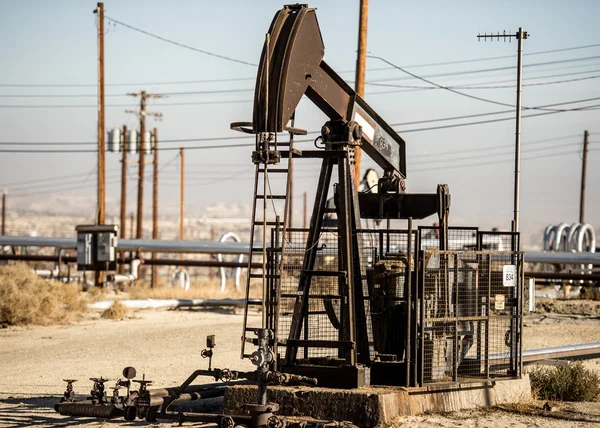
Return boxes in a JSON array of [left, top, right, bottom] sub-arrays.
[[0, 302, 600, 428]]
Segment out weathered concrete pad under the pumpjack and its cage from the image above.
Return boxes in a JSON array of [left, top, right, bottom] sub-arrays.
[[223, 376, 531, 427]]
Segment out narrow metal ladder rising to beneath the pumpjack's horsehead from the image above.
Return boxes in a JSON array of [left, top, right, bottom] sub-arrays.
[[241, 126, 301, 358]]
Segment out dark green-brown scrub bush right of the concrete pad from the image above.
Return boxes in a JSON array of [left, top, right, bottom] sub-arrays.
[[529, 362, 600, 401]]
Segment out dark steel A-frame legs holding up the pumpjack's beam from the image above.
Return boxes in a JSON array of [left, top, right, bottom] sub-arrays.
[[285, 121, 371, 372]]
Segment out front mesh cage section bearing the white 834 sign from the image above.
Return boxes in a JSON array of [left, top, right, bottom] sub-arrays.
[[419, 250, 523, 384]]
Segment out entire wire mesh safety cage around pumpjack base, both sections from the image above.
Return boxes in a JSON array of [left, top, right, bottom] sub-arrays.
[[265, 228, 523, 385]]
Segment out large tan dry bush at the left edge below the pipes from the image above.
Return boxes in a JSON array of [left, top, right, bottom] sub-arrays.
[[0, 264, 86, 325]]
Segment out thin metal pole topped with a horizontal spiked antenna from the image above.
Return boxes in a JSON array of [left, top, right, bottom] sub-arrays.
[[477, 27, 529, 232]]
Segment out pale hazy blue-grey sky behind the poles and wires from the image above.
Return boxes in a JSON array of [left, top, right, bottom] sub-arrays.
[[0, 0, 600, 237]]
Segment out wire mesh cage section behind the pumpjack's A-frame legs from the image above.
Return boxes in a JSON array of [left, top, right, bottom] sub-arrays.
[[269, 228, 416, 360]]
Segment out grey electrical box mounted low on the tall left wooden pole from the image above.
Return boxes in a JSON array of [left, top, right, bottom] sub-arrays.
[[75, 224, 119, 271]]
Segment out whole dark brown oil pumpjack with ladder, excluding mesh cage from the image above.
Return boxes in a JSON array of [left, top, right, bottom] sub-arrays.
[[231, 4, 450, 387]]
